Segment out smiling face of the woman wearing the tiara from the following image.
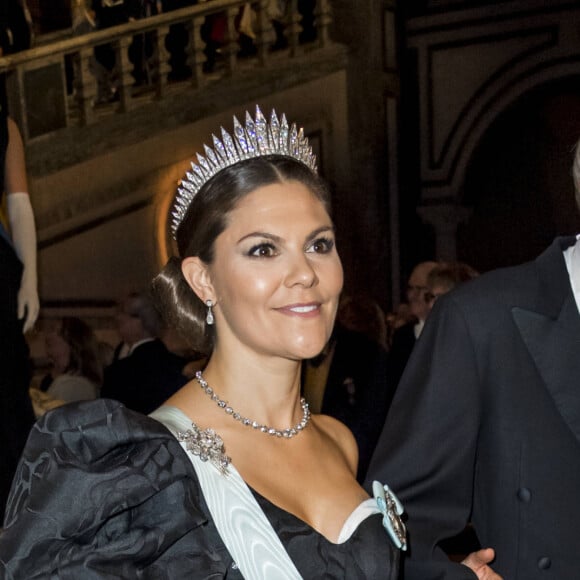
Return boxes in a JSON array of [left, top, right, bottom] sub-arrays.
[[202, 181, 343, 360]]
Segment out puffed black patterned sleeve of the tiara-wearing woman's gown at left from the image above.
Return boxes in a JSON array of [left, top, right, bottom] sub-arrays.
[[0, 399, 236, 579]]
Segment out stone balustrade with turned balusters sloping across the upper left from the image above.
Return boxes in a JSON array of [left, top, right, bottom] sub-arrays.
[[0, 0, 331, 142]]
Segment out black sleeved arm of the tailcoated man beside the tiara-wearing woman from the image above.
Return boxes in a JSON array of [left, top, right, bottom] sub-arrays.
[[366, 299, 481, 580]]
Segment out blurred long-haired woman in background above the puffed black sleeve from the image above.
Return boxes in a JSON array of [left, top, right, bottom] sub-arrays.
[[30, 316, 103, 416]]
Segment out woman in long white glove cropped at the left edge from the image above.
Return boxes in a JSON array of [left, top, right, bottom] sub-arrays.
[[0, 24, 39, 517]]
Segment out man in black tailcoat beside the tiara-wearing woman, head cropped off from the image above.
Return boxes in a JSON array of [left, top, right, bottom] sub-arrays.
[[366, 143, 580, 580]]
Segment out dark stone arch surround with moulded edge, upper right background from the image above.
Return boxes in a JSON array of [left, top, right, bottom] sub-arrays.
[[409, 0, 580, 260]]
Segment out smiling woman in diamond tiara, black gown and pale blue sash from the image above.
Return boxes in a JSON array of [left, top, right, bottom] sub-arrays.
[[0, 109, 498, 580]]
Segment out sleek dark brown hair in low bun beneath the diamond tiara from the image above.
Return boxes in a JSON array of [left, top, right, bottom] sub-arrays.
[[152, 155, 330, 354]]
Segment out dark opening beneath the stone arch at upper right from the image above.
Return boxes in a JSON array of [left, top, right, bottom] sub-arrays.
[[456, 76, 580, 271]]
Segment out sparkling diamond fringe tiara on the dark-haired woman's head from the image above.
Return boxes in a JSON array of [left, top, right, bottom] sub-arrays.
[[171, 105, 317, 238]]
